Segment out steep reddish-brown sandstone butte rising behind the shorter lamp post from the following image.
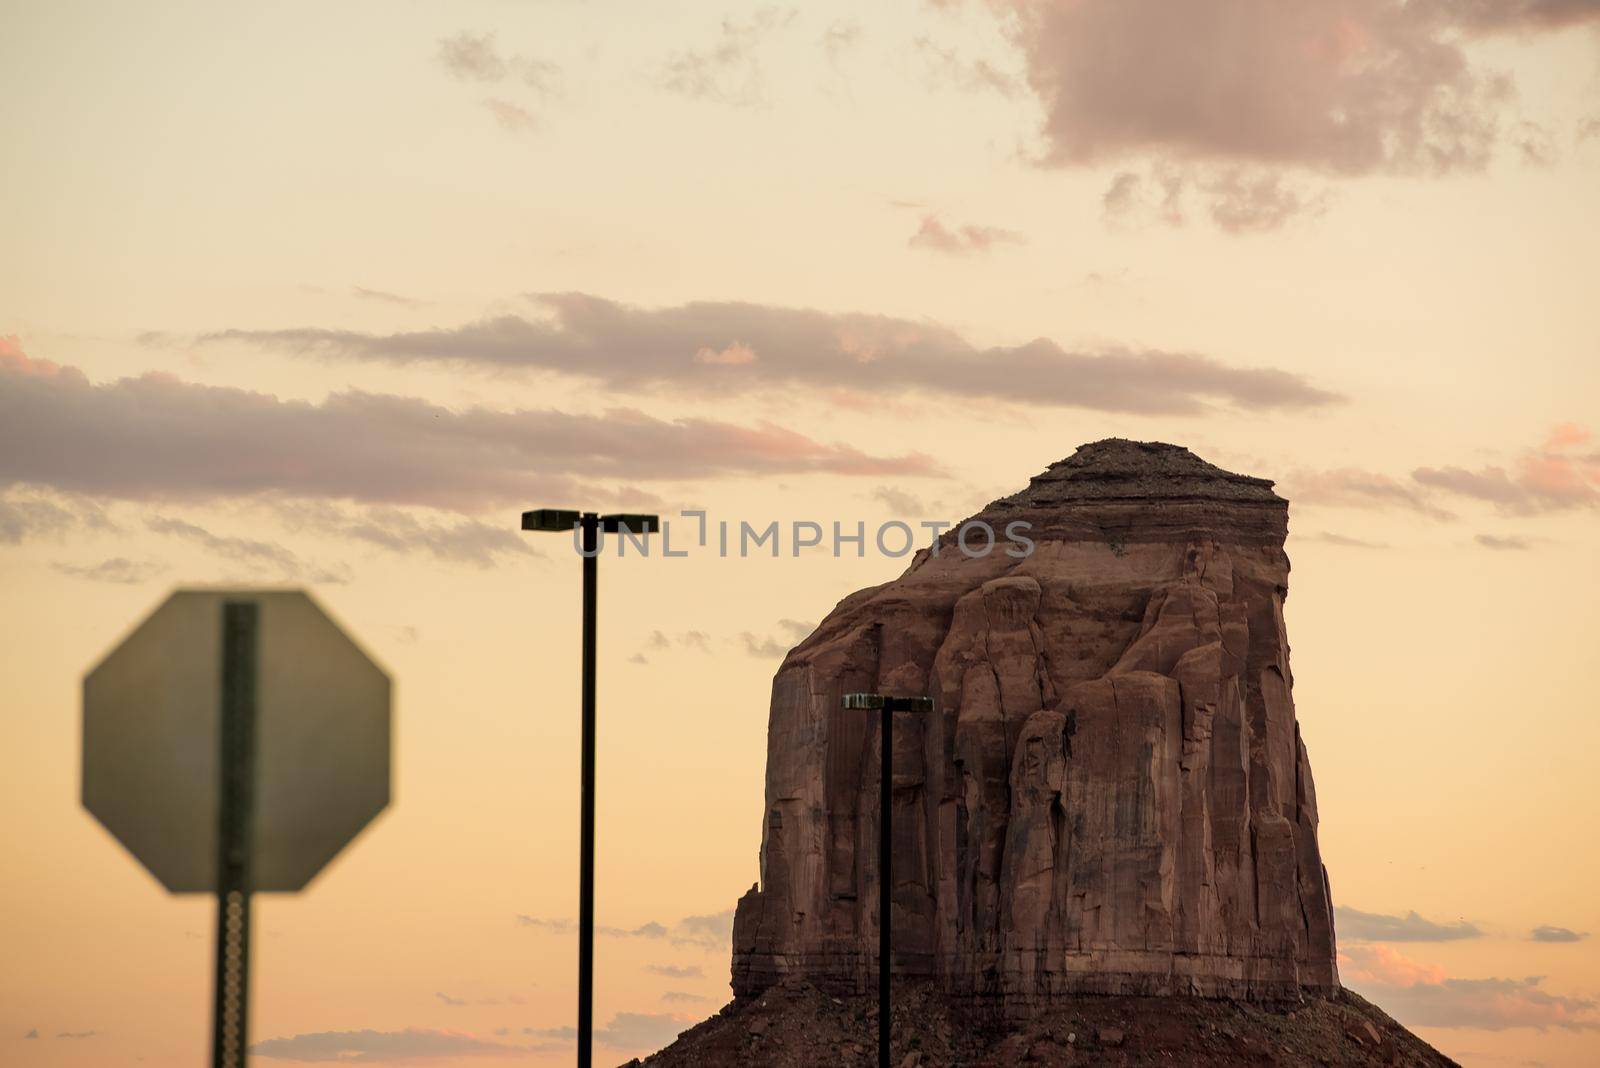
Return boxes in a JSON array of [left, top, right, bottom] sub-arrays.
[[733, 438, 1339, 1015]]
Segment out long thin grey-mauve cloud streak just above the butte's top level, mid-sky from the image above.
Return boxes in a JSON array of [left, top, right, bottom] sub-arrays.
[[198, 293, 1342, 416]]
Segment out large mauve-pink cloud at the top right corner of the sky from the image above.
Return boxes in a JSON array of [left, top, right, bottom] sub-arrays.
[[997, 0, 1600, 232]]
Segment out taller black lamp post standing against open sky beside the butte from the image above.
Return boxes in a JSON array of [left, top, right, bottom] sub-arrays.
[[522, 508, 661, 1068]]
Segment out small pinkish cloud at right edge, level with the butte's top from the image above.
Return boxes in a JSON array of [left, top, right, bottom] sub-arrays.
[[1411, 422, 1600, 515]]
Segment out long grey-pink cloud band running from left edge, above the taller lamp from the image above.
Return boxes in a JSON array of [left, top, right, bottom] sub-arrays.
[[0, 346, 936, 518]]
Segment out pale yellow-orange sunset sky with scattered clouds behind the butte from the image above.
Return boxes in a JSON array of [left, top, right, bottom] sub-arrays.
[[0, 0, 1600, 1068]]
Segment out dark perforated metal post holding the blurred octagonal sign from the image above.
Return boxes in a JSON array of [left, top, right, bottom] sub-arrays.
[[211, 601, 259, 1068]]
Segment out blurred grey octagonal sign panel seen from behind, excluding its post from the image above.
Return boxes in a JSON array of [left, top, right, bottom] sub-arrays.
[[83, 590, 390, 892]]
